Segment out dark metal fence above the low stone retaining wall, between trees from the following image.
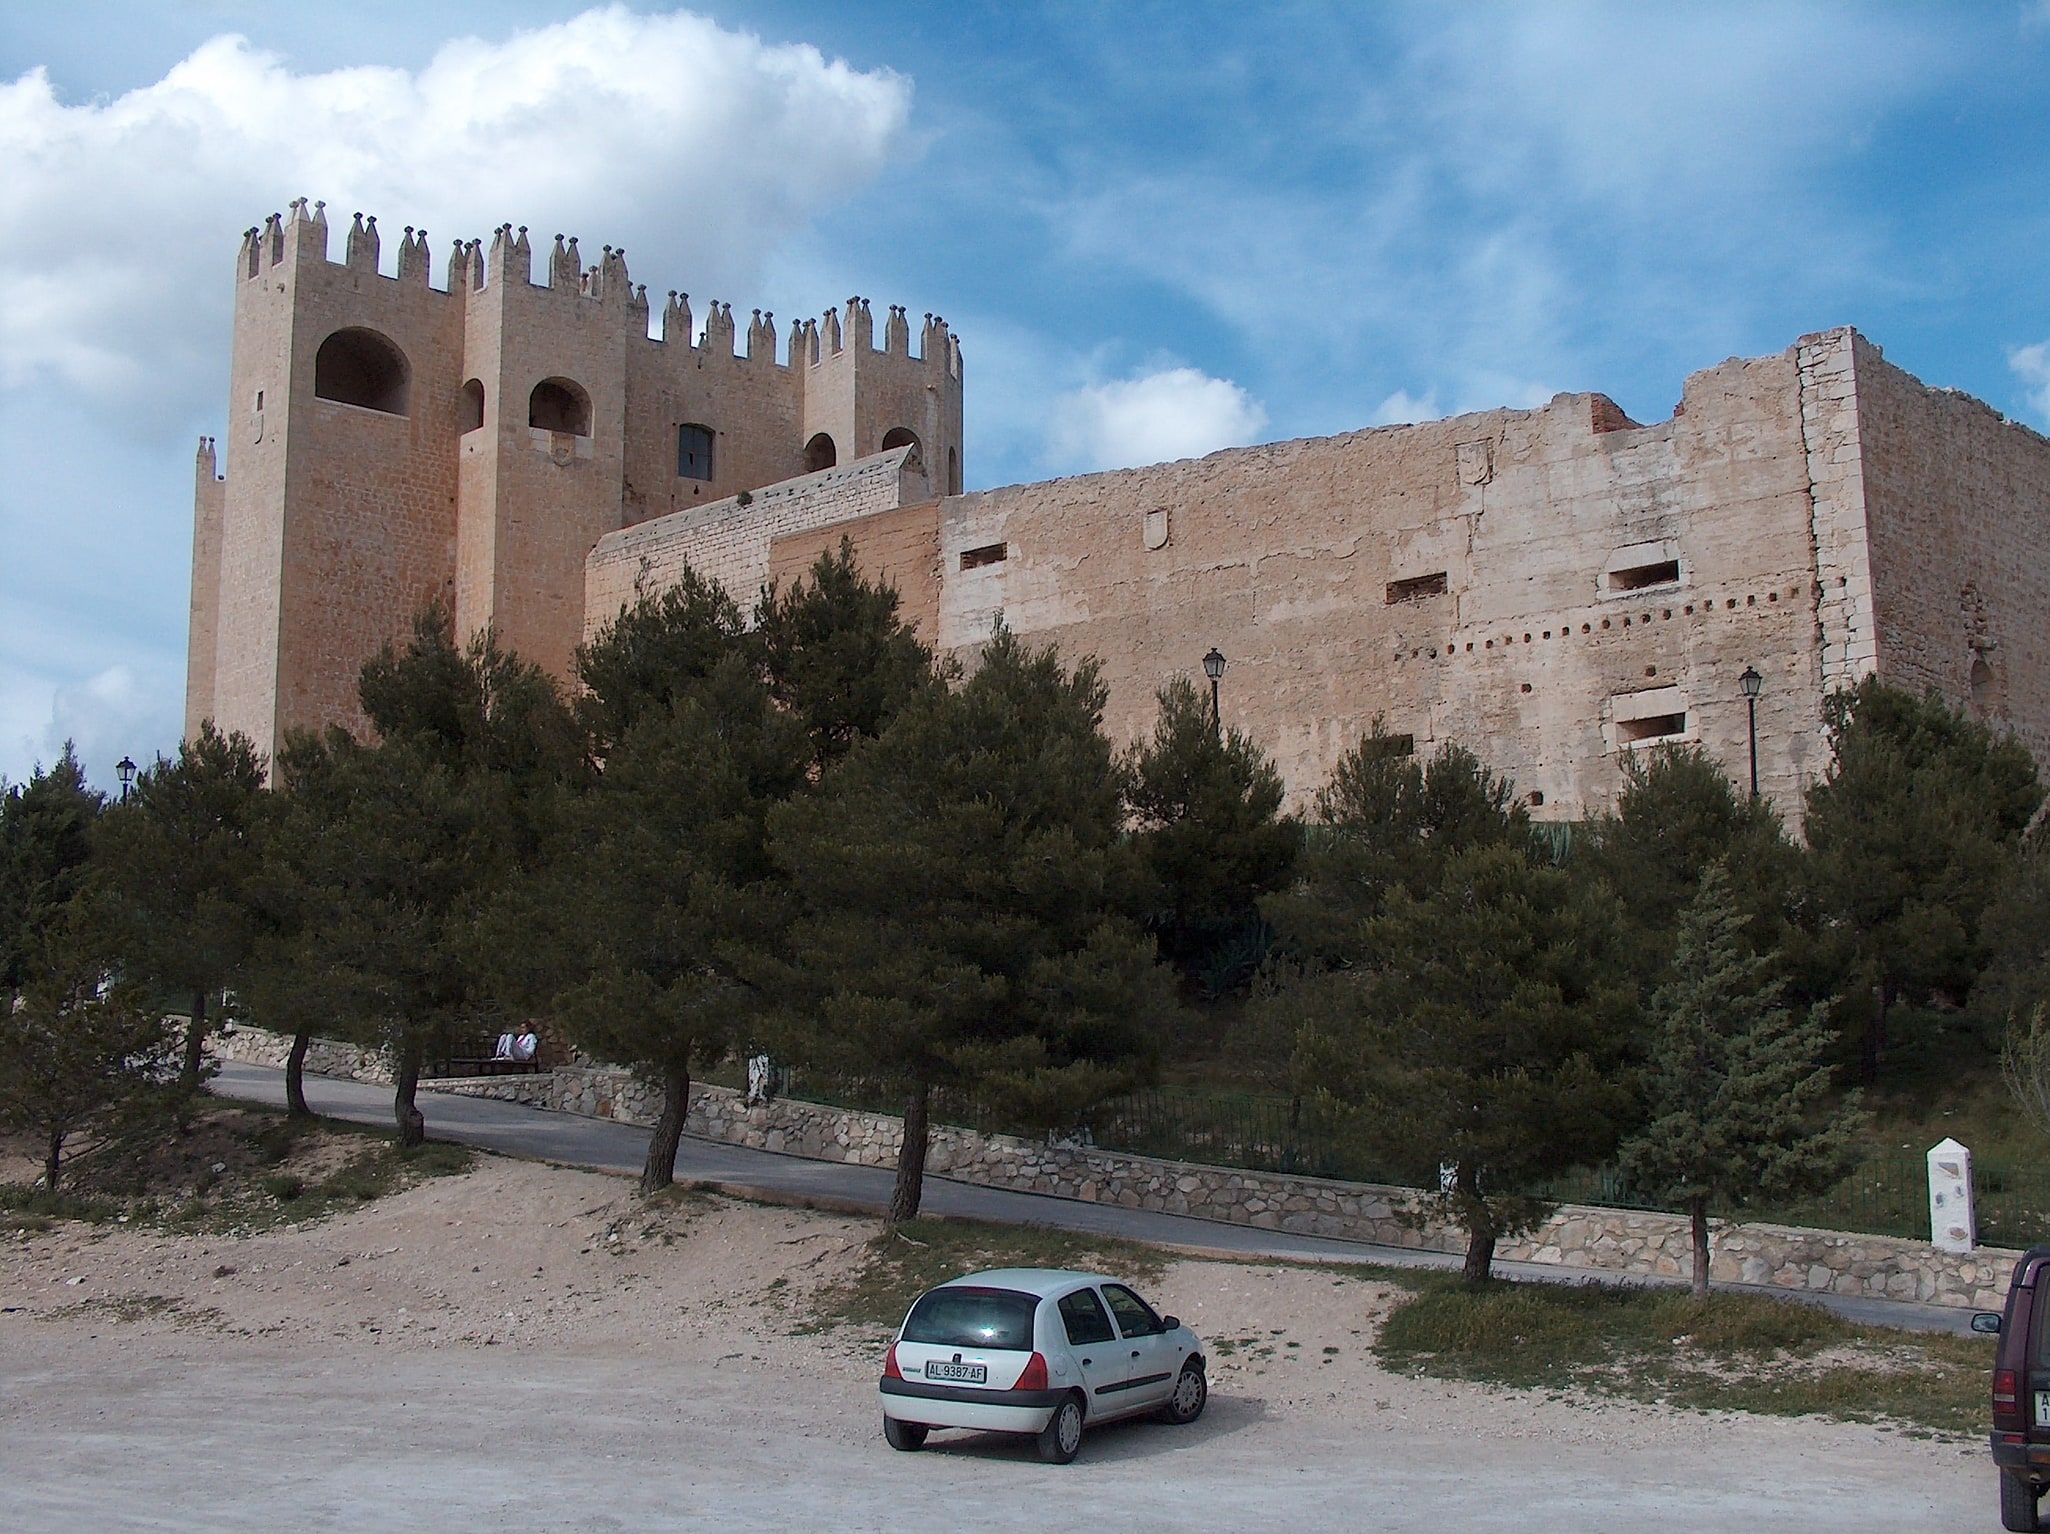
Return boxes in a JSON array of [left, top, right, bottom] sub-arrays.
[[750, 1075, 2050, 1247]]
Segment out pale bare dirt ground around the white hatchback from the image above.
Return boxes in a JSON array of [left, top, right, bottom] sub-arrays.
[[0, 1157, 1995, 1530]]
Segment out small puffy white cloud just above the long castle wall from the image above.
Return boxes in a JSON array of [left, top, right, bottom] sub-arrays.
[[1048, 367, 1267, 470]]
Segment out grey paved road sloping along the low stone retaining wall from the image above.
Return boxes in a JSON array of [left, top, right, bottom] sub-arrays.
[[213, 1062, 1970, 1335]]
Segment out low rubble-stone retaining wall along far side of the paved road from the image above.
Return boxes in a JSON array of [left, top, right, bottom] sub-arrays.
[[422, 1066, 2019, 1310]]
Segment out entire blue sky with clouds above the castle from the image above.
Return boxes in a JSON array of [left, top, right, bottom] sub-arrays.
[[0, 0, 2050, 783]]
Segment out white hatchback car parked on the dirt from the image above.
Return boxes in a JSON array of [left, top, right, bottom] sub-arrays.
[[882, 1267, 1210, 1464]]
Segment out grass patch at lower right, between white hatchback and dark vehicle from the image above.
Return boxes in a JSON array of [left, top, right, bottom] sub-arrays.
[[1374, 1278, 1993, 1436]]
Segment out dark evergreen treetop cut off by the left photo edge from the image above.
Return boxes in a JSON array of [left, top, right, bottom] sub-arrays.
[[0, 742, 107, 1003]]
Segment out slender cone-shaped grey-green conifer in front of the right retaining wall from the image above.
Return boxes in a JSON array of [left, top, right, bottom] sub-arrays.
[[1617, 863, 1861, 1298]]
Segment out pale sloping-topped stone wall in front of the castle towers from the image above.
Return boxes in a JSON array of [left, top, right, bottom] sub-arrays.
[[584, 449, 925, 636]]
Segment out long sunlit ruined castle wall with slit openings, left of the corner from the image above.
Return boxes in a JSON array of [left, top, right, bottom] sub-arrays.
[[941, 355, 1820, 818]]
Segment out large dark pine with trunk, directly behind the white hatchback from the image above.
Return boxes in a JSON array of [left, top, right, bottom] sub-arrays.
[[769, 632, 1173, 1220]]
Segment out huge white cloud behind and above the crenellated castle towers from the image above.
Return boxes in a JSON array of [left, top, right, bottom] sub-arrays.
[[0, 6, 910, 427]]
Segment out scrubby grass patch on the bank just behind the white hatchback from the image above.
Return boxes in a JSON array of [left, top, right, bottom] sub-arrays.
[[800, 1220, 1169, 1331]]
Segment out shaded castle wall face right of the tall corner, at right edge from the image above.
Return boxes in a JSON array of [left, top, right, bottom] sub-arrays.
[[1857, 338, 2050, 761]]
